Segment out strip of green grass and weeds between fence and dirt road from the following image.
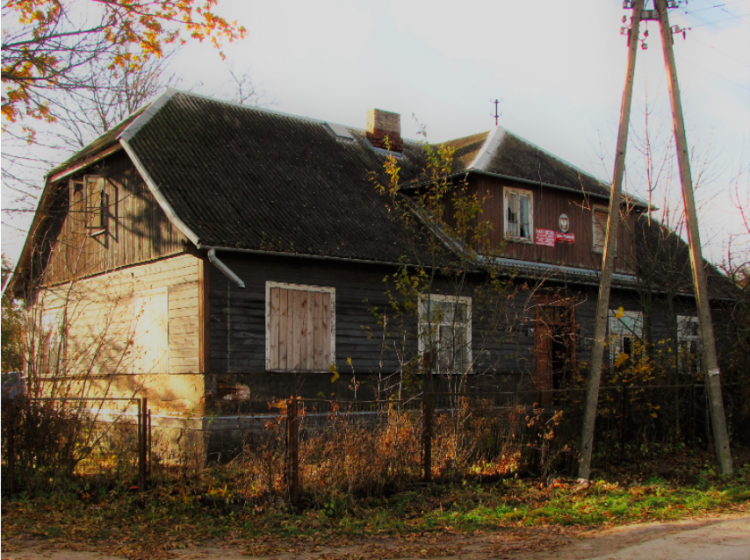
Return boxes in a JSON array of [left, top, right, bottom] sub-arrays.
[[2, 448, 750, 548]]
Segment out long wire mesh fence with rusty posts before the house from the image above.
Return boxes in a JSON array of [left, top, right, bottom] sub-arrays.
[[2, 384, 747, 504]]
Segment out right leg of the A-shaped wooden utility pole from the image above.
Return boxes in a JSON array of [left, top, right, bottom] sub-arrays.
[[656, 0, 732, 474]]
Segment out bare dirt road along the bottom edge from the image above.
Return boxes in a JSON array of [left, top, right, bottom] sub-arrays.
[[2, 516, 750, 560]]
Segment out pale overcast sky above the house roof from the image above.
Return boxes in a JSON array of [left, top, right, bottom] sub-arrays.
[[3, 0, 750, 261]]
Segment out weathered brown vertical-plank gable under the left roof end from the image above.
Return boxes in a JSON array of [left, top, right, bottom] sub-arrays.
[[34, 152, 187, 284]]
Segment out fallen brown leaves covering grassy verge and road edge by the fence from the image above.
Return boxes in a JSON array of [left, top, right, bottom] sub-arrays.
[[2, 450, 750, 560]]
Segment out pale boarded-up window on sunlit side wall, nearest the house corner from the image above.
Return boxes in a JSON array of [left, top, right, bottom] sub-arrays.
[[133, 288, 169, 373]]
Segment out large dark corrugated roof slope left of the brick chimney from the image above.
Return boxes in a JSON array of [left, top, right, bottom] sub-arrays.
[[129, 93, 428, 262]]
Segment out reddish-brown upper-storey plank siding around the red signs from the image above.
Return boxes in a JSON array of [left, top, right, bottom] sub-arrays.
[[471, 177, 634, 272]]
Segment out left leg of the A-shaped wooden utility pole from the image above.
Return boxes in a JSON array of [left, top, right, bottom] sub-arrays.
[[578, 0, 644, 480]]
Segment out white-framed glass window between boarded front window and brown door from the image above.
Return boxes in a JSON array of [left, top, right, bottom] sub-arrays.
[[419, 294, 472, 373]]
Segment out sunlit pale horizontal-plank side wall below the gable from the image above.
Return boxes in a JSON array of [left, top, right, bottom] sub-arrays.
[[35, 254, 204, 413]]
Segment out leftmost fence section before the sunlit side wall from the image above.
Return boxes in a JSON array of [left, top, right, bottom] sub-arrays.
[[2, 395, 151, 493]]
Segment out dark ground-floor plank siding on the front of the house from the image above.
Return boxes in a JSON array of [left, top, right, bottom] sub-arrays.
[[207, 252, 716, 411]]
